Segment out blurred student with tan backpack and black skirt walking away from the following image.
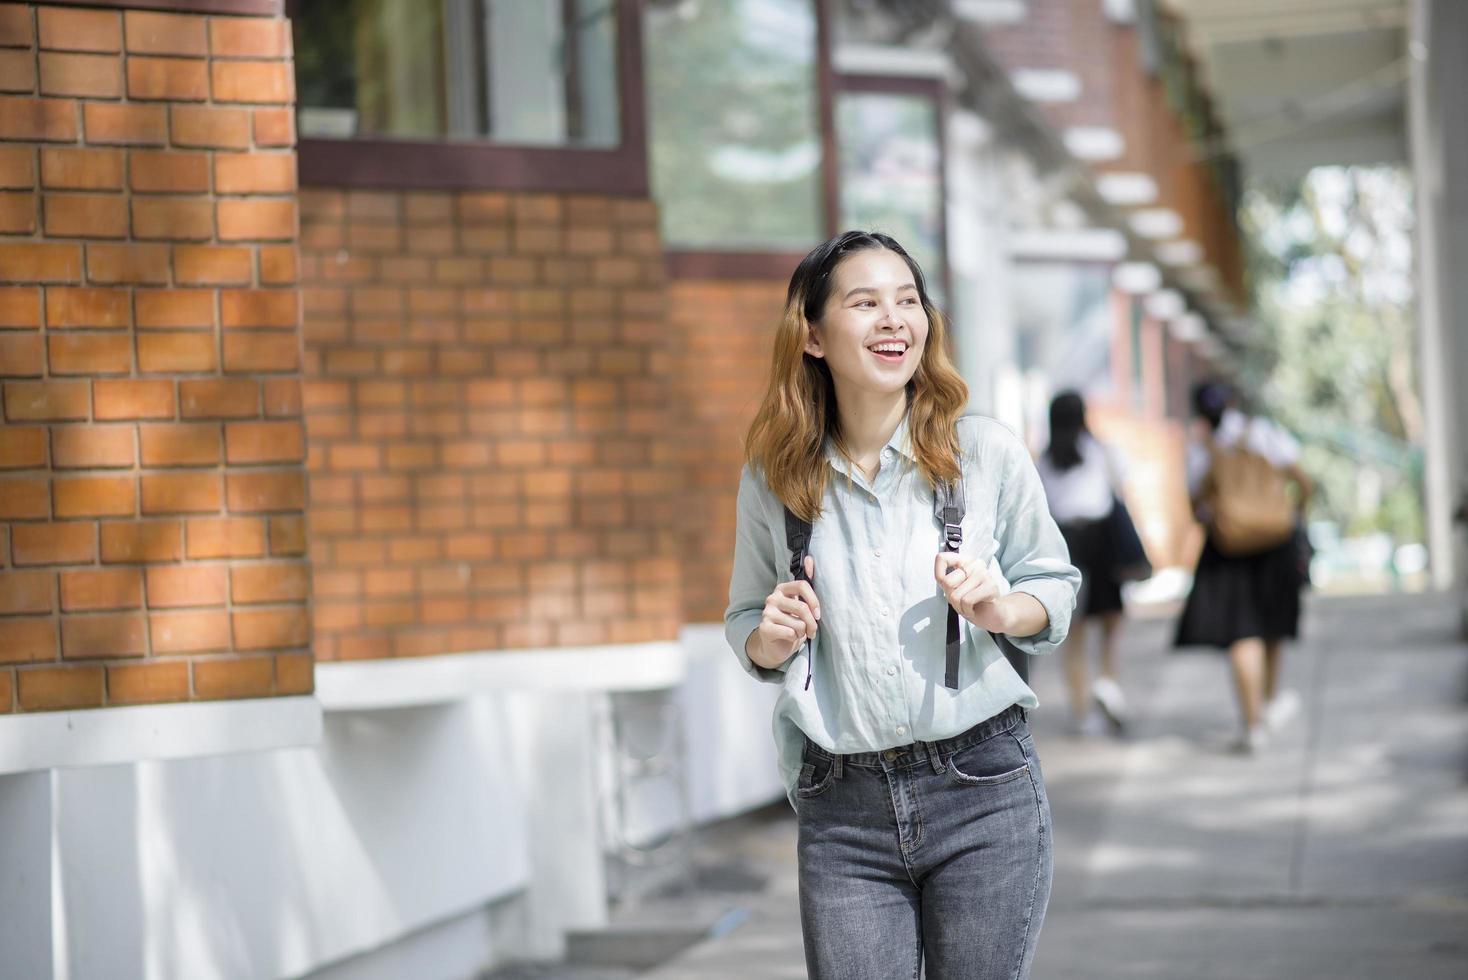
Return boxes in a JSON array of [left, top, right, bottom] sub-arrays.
[[1176, 381, 1311, 753]]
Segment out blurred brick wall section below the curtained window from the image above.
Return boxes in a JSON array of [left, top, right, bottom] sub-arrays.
[[299, 188, 697, 660]]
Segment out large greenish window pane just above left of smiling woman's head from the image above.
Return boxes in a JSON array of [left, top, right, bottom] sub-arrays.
[[643, 0, 824, 251]]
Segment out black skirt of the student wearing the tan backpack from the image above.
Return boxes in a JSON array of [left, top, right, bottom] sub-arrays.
[[1173, 537, 1305, 648]]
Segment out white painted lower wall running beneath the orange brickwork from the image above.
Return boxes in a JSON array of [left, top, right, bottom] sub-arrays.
[[0, 625, 784, 980]]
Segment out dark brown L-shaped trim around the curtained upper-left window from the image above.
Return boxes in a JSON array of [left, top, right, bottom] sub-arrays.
[[291, 0, 647, 197]]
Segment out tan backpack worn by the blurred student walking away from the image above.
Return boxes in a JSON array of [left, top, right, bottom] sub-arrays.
[[1202, 446, 1295, 557]]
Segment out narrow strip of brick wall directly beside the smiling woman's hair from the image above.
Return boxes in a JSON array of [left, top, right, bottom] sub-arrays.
[[668, 280, 785, 622]]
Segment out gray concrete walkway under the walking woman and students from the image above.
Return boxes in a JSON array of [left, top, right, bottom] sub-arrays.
[[643, 596, 1468, 980]]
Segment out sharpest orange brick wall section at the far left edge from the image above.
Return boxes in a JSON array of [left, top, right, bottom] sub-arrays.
[[0, 3, 311, 712]]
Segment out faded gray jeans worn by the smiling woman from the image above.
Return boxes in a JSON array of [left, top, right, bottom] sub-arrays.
[[796, 706, 1051, 980]]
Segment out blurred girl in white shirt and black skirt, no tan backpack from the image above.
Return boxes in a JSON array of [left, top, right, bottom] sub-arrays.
[[1035, 392, 1135, 735]]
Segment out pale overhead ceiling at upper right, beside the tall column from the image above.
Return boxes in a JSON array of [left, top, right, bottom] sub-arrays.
[[1161, 0, 1408, 179]]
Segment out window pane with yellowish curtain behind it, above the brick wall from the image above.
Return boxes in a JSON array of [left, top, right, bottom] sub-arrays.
[[294, 0, 619, 147]]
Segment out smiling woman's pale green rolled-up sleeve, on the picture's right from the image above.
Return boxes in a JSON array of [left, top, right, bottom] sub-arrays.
[[995, 430, 1080, 654]]
